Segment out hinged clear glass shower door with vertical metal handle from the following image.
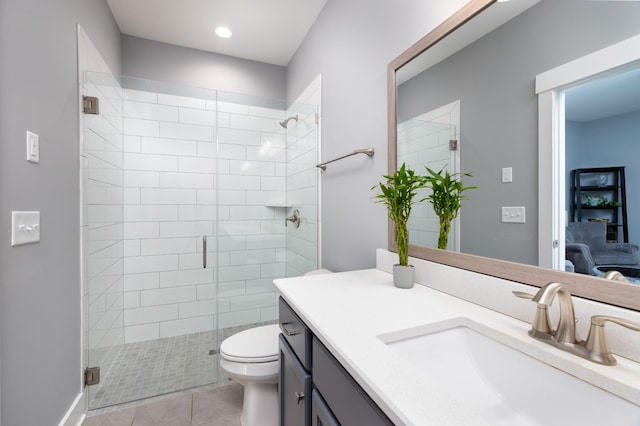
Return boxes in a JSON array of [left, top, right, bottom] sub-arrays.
[[85, 73, 218, 409]]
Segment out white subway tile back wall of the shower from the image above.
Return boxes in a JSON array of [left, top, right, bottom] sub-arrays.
[[120, 89, 290, 343]]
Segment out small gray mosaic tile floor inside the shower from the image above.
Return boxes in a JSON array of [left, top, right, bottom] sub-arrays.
[[89, 324, 263, 410]]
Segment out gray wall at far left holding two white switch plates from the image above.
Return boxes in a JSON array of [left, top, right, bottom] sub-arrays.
[[0, 0, 120, 426]]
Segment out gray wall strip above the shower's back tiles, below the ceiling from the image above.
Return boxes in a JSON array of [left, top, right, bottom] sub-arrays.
[[122, 35, 286, 100]]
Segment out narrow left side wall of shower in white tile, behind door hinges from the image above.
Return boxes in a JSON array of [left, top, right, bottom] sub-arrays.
[[80, 73, 124, 408]]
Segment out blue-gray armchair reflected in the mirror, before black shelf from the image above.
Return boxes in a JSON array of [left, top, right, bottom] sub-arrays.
[[566, 222, 640, 275]]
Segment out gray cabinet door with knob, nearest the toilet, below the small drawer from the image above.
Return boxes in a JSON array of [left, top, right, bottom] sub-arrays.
[[278, 334, 311, 426]]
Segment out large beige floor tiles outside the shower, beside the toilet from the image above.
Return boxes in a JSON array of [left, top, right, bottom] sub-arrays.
[[82, 381, 243, 426]]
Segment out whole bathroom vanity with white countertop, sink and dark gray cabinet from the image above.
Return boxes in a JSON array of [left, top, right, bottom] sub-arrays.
[[275, 253, 640, 426]]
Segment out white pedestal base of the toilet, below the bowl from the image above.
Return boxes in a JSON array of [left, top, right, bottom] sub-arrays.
[[240, 382, 280, 426]]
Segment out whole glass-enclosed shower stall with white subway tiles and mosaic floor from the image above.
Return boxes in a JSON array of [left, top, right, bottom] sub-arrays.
[[80, 72, 320, 409]]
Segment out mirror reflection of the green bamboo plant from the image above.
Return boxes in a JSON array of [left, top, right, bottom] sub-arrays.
[[424, 167, 478, 250]]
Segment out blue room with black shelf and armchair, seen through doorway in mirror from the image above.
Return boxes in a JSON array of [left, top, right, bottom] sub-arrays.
[[564, 68, 640, 282]]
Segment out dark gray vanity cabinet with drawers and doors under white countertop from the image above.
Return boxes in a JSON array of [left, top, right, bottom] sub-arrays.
[[279, 298, 393, 426]]
